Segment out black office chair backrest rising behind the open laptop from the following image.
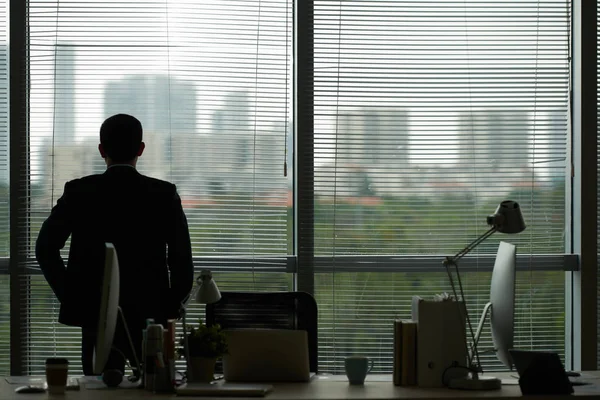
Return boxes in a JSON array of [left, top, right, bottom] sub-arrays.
[[206, 292, 319, 373]]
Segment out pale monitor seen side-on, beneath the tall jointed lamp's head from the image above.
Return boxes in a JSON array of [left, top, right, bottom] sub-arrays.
[[475, 242, 517, 369]]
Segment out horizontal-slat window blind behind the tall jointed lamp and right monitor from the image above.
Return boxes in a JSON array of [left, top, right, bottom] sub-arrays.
[[314, 0, 570, 373]]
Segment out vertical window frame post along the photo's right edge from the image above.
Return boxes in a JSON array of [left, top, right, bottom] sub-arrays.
[[565, 0, 598, 370]]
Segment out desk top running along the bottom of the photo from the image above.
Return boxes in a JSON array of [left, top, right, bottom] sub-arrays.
[[0, 371, 600, 400]]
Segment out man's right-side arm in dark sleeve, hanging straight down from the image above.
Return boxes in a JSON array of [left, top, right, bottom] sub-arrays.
[[167, 189, 194, 307]]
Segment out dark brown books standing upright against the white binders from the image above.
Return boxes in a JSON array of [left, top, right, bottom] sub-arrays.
[[393, 319, 417, 386]]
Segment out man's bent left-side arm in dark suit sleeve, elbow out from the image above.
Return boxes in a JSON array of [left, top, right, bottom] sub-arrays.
[[35, 182, 72, 303]]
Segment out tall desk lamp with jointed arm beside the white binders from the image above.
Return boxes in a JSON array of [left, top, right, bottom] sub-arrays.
[[444, 200, 525, 390]]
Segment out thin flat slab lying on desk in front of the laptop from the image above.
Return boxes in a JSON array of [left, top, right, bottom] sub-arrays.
[[175, 382, 273, 397]]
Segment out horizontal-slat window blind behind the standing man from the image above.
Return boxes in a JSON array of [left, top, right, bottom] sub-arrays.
[[22, 0, 293, 373]]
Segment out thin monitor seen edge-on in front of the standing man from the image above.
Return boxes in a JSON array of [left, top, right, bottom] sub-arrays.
[[94, 243, 119, 375]]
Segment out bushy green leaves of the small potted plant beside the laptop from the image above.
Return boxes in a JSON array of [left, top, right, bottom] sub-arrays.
[[179, 320, 228, 358]]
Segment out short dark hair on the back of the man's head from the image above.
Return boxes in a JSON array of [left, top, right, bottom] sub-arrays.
[[100, 114, 142, 162]]
